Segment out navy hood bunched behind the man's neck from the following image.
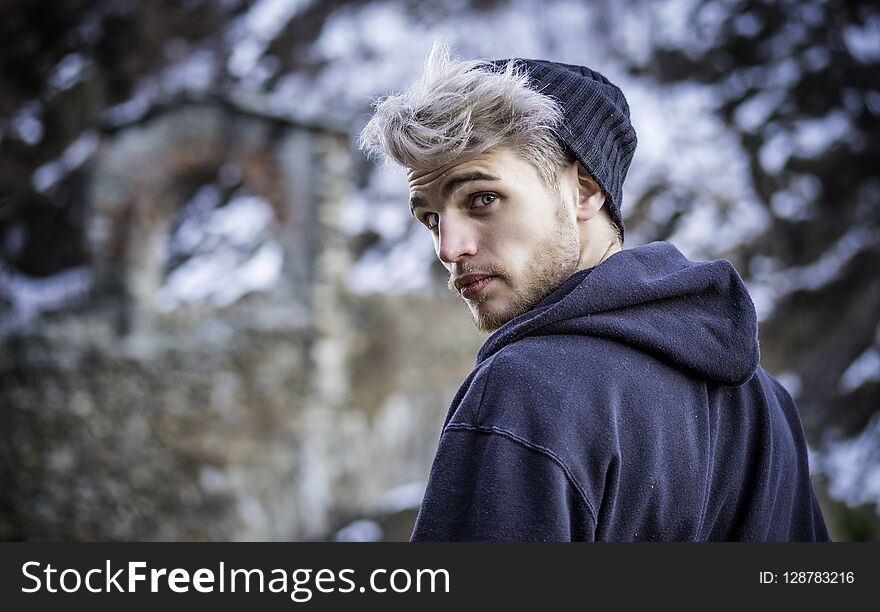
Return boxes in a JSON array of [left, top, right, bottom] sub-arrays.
[[477, 242, 760, 385]]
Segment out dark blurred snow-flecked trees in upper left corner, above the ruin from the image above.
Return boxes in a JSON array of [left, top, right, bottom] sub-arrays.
[[0, 0, 362, 284]]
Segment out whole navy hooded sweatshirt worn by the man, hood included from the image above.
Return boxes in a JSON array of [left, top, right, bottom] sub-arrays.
[[412, 242, 829, 541]]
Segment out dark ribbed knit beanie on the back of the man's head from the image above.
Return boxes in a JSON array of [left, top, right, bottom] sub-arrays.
[[491, 58, 636, 233]]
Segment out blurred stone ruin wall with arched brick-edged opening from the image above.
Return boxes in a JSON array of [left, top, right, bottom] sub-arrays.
[[0, 102, 477, 540]]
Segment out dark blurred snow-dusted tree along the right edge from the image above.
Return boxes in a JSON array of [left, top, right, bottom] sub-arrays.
[[620, 0, 880, 439]]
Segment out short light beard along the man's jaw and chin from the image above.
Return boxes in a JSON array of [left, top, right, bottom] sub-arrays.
[[448, 205, 580, 333]]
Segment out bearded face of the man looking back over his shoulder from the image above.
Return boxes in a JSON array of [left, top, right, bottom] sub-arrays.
[[408, 147, 581, 332]]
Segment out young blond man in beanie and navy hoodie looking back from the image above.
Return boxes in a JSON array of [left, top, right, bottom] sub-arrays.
[[361, 48, 828, 541]]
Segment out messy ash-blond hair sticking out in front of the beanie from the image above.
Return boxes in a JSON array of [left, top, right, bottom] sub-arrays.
[[359, 42, 574, 189]]
